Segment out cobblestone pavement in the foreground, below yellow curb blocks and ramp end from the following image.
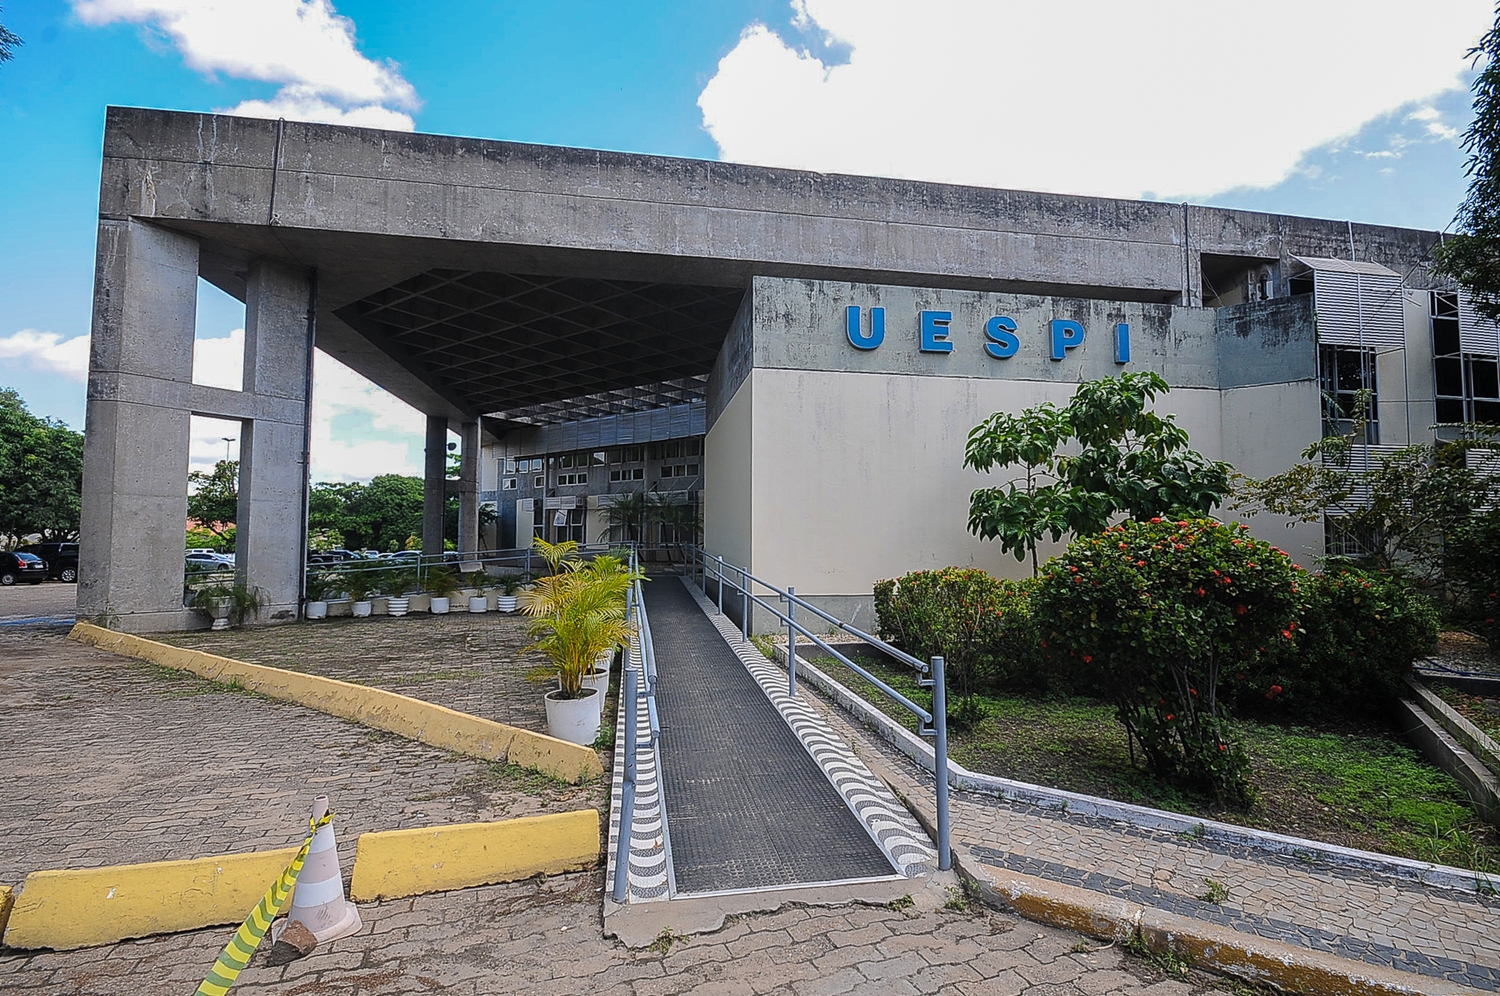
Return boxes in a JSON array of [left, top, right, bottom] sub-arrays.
[[0, 873, 1227, 996]]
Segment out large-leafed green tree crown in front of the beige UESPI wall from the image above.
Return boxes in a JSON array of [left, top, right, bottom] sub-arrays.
[[963, 372, 1232, 573]]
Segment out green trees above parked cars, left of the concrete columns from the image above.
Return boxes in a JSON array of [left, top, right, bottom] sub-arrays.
[[0, 387, 84, 546]]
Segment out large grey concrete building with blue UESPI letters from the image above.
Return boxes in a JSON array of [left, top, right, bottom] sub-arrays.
[[80, 108, 1500, 630]]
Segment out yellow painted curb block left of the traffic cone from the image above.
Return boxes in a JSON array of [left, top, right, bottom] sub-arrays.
[[5, 848, 297, 951]]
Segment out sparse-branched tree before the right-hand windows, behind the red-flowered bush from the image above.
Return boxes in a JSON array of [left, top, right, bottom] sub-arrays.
[[1235, 392, 1497, 584]]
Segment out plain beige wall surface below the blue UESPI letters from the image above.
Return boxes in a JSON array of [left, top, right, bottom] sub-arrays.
[[720, 368, 1322, 596]]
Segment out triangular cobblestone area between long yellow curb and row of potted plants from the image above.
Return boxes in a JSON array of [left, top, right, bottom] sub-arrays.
[[153, 612, 549, 732]]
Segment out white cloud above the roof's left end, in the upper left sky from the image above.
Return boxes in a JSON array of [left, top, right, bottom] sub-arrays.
[[74, 0, 420, 131]]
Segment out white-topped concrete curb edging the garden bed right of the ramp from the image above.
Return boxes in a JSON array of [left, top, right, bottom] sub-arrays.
[[776, 647, 1479, 893]]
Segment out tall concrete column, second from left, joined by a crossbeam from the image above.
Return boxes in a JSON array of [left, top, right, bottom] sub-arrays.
[[236, 260, 314, 623]]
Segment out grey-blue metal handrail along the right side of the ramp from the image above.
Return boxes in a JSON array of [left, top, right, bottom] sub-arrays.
[[687, 546, 953, 872]]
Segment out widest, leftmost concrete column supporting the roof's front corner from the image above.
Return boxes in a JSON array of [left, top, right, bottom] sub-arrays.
[[78, 219, 198, 632]]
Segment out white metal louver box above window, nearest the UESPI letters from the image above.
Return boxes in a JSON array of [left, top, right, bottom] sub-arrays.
[[1296, 257, 1406, 350]]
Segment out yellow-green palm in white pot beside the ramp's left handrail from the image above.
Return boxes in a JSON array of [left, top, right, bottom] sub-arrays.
[[521, 557, 639, 744]]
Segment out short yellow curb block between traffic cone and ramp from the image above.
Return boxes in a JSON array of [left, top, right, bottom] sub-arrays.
[[350, 809, 599, 902]]
